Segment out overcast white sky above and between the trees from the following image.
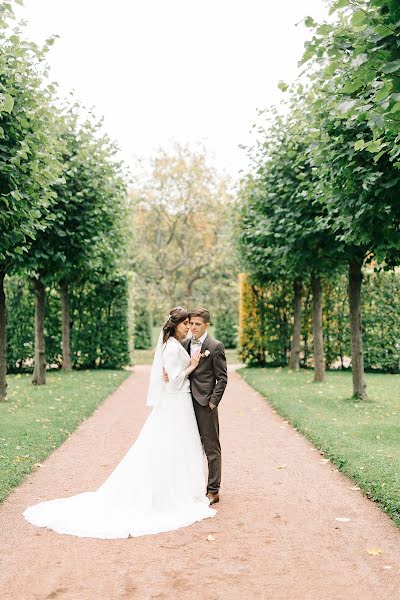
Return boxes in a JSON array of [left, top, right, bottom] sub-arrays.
[[14, 0, 328, 175]]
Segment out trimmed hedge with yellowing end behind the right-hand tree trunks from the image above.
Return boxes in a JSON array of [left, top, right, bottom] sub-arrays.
[[239, 271, 400, 373]]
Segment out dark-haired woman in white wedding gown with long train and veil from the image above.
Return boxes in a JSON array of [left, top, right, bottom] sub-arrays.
[[23, 307, 216, 539]]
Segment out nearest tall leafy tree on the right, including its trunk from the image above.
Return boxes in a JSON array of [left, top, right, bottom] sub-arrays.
[[304, 0, 400, 398]]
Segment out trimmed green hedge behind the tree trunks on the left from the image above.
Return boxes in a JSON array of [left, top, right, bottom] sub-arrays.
[[6, 276, 130, 372]]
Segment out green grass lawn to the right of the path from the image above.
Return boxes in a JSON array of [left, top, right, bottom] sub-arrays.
[[239, 369, 400, 526]]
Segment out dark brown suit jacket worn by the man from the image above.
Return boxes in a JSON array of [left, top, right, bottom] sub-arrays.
[[182, 334, 228, 406]]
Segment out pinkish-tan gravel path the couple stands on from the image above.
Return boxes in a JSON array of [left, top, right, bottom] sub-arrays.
[[0, 366, 400, 600]]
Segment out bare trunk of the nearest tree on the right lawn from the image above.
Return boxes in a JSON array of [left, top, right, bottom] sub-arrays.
[[349, 259, 367, 400]]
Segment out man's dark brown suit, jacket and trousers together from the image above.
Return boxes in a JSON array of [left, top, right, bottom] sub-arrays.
[[182, 334, 228, 494]]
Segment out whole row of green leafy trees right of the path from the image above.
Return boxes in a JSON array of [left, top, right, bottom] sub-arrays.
[[240, 0, 400, 398]]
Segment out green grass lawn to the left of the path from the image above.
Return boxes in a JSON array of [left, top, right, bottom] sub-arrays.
[[0, 369, 130, 502]]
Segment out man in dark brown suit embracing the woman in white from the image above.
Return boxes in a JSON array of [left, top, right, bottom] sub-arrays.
[[182, 308, 228, 506]]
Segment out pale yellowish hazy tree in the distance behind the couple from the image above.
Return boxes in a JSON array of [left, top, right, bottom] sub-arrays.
[[131, 145, 237, 319]]
